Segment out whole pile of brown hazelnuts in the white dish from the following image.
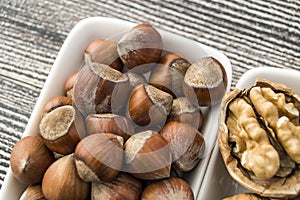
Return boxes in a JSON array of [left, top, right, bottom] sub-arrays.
[[11, 24, 227, 200]]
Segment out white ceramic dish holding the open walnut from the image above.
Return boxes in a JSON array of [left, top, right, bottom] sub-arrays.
[[198, 67, 300, 200]]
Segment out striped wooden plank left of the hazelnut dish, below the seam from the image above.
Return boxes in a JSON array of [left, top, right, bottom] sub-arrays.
[[0, 75, 40, 182]]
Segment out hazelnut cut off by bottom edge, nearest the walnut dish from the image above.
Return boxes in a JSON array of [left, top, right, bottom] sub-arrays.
[[141, 177, 195, 200]]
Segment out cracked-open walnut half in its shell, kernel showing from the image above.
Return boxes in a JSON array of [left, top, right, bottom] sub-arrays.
[[218, 79, 300, 198]]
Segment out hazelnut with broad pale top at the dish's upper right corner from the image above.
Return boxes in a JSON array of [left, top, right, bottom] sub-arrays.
[[183, 57, 227, 106]]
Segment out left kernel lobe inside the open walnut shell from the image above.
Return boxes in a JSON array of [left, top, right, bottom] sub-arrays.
[[226, 98, 280, 178]]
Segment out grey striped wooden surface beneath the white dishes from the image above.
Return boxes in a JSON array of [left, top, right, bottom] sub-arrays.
[[0, 0, 300, 187]]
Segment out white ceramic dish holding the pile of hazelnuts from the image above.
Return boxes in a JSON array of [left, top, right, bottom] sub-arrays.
[[0, 17, 232, 200]]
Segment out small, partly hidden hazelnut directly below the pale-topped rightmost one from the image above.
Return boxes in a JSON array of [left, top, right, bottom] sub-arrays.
[[167, 97, 204, 131]]
